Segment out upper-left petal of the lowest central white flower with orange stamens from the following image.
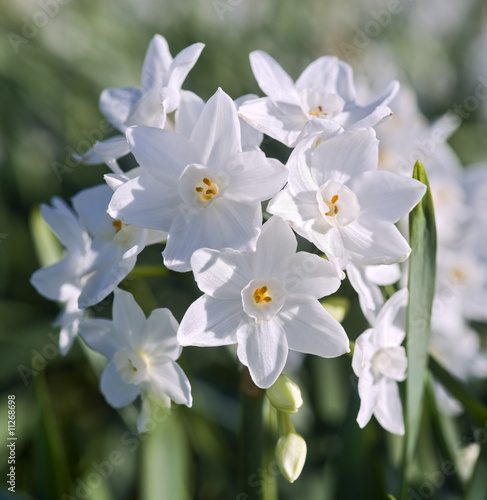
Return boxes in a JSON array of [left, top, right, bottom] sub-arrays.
[[191, 248, 252, 299]]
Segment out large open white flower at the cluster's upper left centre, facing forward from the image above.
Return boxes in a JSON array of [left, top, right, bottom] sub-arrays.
[[109, 89, 287, 271]]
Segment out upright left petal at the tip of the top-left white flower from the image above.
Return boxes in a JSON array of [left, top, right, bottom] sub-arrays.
[[142, 35, 172, 90]]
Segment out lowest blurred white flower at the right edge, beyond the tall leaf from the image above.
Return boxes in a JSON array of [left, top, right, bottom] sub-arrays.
[[429, 306, 487, 415]]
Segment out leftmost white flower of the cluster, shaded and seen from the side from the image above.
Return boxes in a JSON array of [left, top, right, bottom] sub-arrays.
[[31, 198, 96, 355]]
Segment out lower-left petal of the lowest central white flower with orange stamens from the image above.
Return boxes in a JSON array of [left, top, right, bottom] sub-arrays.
[[178, 295, 245, 347]]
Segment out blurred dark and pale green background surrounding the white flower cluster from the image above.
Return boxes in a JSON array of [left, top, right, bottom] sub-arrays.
[[0, 0, 487, 500]]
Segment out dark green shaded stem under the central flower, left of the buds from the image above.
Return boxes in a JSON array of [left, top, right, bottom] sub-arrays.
[[239, 367, 265, 500]]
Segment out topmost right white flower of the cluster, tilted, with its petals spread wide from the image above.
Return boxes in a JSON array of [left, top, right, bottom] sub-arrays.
[[239, 50, 399, 147]]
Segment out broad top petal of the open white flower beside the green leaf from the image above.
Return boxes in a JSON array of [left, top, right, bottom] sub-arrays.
[[311, 129, 379, 186]]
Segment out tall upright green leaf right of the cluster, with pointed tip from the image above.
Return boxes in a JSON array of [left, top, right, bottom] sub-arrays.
[[402, 161, 436, 498]]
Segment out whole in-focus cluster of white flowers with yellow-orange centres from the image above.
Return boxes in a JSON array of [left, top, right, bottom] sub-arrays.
[[32, 35, 446, 444]]
